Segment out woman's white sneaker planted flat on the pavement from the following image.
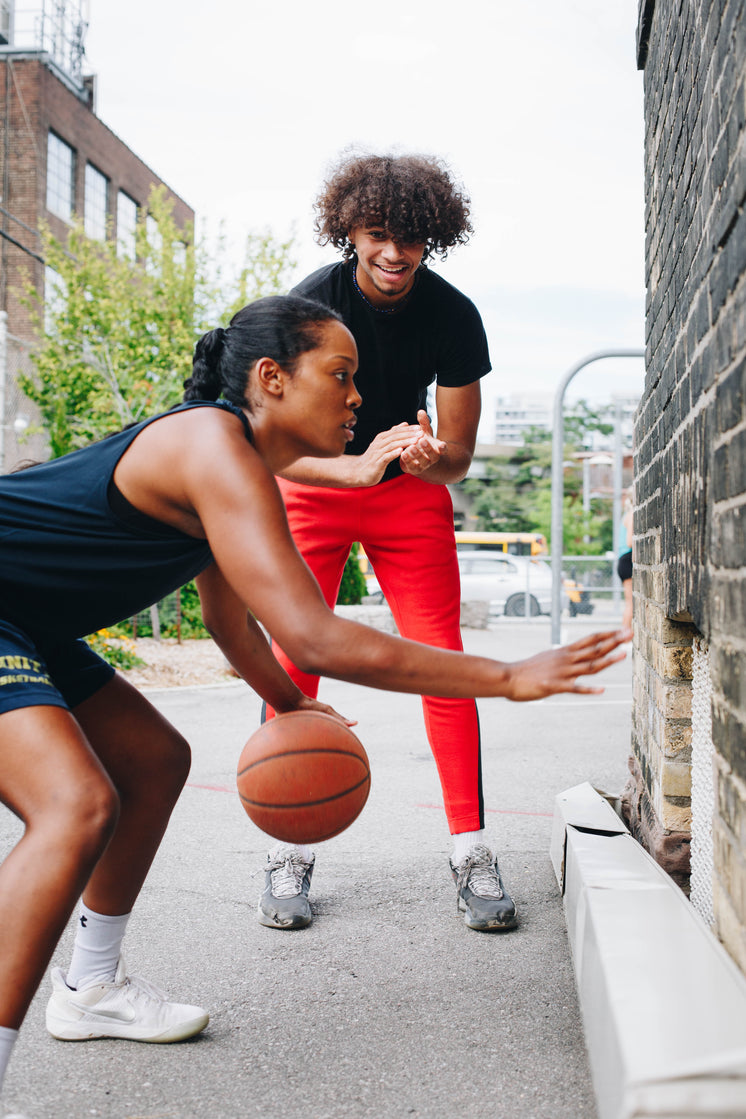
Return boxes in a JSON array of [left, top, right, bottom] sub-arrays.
[[47, 956, 209, 1042]]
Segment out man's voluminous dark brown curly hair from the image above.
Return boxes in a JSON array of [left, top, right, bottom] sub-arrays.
[[314, 152, 473, 260]]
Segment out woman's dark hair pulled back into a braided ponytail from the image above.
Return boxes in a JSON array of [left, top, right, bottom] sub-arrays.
[[183, 295, 342, 407]]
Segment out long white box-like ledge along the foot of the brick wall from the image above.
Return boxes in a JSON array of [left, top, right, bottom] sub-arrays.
[[550, 783, 746, 1119]]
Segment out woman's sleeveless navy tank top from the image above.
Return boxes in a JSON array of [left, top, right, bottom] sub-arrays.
[[0, 401, 251, 639]]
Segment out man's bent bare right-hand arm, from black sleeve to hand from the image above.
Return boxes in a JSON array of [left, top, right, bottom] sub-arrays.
[[400, 380, 482, 485]]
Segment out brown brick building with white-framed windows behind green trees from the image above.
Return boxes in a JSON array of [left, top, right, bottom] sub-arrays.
[[0, 0, 195, 470]]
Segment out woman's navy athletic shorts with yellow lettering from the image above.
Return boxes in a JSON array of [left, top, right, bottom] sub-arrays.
[[0, 619, 114, 714]]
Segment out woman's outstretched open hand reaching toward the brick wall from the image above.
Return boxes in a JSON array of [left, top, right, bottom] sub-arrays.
[[506, 630, 632, 702]]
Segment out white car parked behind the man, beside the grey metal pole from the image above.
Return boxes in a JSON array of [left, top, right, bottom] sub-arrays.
[[459, 549, 551, 618]]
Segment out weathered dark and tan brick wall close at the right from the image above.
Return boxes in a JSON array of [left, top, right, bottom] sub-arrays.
[[625, 0, 746, 970]]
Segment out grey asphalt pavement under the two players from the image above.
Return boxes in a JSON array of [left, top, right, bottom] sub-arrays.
[[0, 619, 631, 1119]]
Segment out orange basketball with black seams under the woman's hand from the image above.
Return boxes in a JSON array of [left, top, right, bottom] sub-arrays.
[[236, 711, 370, 844]]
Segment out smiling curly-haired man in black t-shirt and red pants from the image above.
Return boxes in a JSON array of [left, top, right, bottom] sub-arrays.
[[258, 156, 516, 931]]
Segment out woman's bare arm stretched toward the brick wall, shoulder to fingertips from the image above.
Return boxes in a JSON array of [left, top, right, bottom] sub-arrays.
[[180, 429, 630, 699]]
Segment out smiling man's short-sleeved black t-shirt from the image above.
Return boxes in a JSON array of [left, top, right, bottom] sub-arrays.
[[293, 257, 492, 479]]
